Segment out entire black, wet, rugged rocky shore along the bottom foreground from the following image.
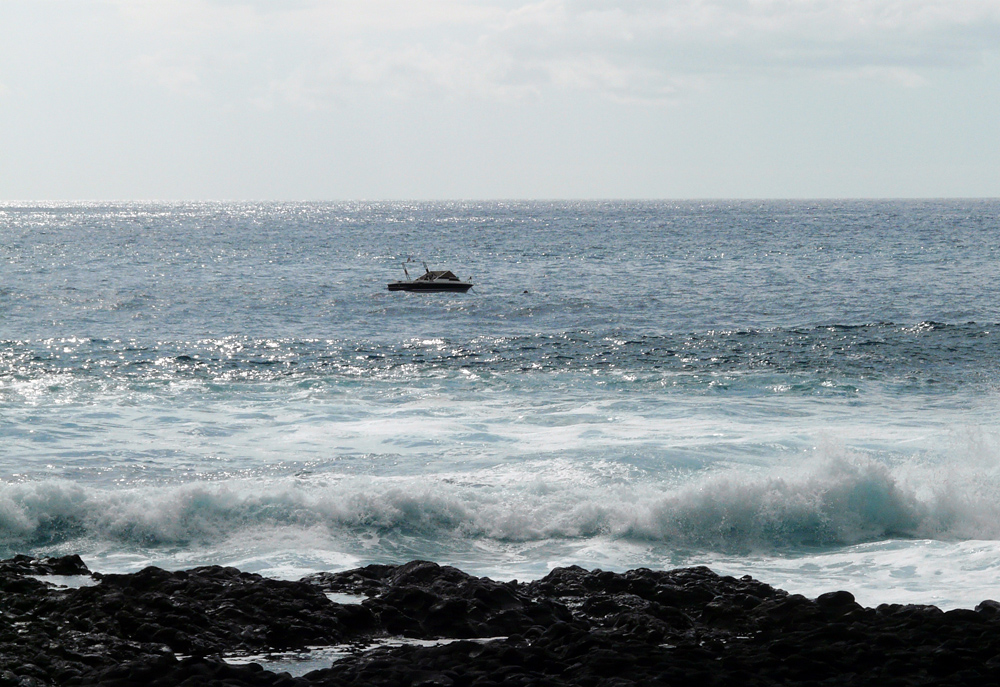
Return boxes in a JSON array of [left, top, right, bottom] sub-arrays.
[[0, 556, 1000, 687]]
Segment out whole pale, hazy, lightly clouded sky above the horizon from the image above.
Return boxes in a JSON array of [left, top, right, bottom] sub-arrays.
[[0, 0, 1000, 201]]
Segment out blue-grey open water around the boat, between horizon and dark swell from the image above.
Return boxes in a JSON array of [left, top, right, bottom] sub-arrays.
[[7, 201, 1000, 341]]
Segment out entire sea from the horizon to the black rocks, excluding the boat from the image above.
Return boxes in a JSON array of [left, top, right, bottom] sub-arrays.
[[0, 200, 1000, 608]]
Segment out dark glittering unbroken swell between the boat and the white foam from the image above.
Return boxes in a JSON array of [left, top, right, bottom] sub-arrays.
[[0, 322, 1000, 391]]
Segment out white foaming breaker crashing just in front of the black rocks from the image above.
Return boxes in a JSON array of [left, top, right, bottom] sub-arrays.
[[0, 456, 1000, 553]]
